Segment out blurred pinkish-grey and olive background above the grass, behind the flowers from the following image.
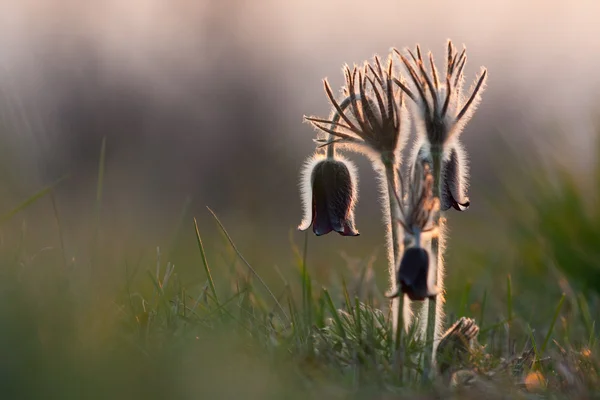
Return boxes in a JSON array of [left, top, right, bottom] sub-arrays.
[[0, 0, 600, 396]]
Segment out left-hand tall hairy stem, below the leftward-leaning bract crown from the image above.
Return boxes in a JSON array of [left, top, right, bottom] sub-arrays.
[[382, 154, 405, 380]]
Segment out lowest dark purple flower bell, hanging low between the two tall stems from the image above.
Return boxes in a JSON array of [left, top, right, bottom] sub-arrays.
[[398, 247, 437, 301]]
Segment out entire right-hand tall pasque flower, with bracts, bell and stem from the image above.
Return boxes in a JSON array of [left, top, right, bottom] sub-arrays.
[[394, 41, 487, 376]]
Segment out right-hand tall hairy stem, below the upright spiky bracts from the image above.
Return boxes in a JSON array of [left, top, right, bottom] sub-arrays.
[[423, 146, 444, 380]]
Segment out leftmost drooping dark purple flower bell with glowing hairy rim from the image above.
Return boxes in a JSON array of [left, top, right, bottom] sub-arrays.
[[298, 155, 359, 236]]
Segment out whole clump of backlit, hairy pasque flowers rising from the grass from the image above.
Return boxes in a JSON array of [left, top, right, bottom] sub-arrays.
[[299, 42, 487, 377]]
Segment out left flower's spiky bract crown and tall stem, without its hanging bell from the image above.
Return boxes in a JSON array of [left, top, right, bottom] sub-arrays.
[[306, 56, 410, 338]]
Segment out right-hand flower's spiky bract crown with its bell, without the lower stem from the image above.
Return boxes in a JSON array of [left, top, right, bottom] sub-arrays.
[[395, 41, 487, 211]]
